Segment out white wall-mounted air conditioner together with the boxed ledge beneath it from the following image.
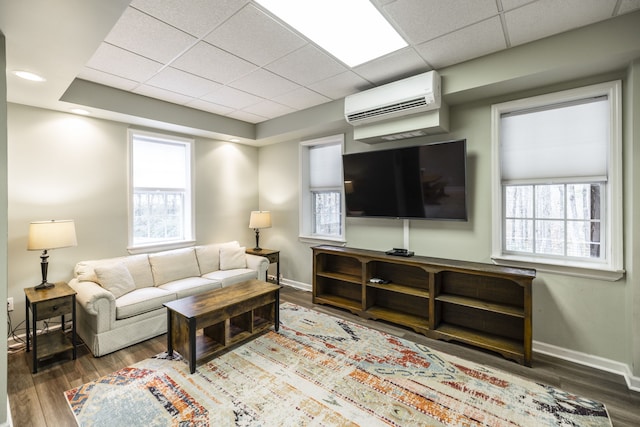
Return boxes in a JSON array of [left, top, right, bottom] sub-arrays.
[[344, 71, 449, 144]]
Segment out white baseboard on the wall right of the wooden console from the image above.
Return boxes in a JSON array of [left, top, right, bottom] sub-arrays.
[[533, 341, 640, 391]]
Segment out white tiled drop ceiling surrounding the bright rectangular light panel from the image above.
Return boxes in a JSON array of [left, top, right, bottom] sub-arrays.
[[51, 0, 640, 123]]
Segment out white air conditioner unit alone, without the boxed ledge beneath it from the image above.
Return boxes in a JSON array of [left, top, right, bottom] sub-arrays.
[[344, 71, 440, 126]]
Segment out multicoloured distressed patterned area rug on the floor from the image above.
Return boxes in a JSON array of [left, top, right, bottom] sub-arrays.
[[65, 303, 611, 427]]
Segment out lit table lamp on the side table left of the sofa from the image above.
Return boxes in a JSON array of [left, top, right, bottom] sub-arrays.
[[27, 219, 78, 290]]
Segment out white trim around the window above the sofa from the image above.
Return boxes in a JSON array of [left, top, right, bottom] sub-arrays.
[[127, 129, 196, 254]]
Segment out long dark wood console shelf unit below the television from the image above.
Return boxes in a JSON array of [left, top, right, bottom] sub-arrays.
[[313, 245, 536, 366]]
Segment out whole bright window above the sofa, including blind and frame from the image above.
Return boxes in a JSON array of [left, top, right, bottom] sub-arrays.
[[129, 131, 194, 248]]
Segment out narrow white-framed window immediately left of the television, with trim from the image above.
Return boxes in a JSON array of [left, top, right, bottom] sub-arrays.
[[300, 135, 344, 241]]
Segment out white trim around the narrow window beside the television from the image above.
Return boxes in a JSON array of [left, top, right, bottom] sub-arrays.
[[298, 134, 346, 245]]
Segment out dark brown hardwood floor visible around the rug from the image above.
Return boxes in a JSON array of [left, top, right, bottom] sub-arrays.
[[7, 287, 640, 427]]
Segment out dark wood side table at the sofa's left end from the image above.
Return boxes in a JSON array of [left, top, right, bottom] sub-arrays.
[[24, 282, 76, 374]]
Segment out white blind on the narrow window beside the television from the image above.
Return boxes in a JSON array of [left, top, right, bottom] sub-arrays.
[[309, 144, 342, 188]]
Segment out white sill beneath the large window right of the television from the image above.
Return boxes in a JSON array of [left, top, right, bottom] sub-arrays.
[[491, 255, 625, 282]]
